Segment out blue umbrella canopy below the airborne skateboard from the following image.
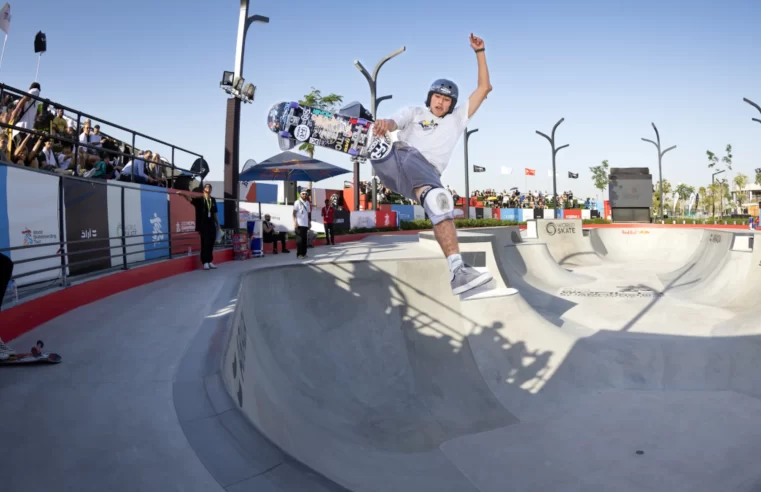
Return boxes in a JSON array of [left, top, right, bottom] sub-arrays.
[[239, 151, 351, 182]]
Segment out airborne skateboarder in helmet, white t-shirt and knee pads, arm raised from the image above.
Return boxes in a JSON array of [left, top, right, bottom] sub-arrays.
[[371, 33, 492, 295]]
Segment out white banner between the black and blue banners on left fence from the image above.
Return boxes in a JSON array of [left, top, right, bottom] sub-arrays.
[[106, 182, 145, 267]]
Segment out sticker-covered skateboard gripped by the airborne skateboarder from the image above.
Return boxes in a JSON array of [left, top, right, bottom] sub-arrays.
[[267, 102, 391, 160]]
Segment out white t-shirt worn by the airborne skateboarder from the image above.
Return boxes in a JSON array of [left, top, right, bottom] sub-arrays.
[[392, 98, 469, 174]]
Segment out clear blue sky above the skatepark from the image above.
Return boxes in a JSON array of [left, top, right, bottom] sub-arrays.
[[0, 0, 761, 200]]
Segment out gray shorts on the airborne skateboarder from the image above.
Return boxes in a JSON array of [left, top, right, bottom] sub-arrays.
[[370, 142, 443, 201]]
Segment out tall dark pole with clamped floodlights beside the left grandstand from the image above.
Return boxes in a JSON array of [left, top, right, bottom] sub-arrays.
[[220, 0, 270, 230]]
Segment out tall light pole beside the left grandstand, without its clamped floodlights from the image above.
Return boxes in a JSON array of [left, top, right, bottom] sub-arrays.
[[223, 0, 270, 231]]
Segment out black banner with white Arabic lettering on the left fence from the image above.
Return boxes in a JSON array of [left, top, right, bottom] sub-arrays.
[[63, 179, 111, 276]]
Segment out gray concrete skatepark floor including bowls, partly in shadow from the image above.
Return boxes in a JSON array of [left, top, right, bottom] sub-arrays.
[[0, 228, 761, 492]]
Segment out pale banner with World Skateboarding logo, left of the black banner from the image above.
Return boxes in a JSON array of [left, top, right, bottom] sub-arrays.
[[0, 166, 60, 286]]
